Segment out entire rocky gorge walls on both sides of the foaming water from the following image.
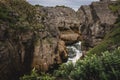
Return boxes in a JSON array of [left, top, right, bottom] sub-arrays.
[[0, 0, 120, 80]]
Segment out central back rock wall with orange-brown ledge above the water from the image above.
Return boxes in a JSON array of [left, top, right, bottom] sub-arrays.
[[45, 6, 81, 45]]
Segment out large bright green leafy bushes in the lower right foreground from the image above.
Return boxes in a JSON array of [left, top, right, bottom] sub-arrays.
[[54, 48, 120, 80]]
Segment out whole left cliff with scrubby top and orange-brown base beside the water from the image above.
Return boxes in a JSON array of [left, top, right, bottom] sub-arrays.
[[0, 0, 68, 80]]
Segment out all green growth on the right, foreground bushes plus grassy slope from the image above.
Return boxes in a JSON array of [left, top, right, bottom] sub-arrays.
[[54, 0, 120, 80]]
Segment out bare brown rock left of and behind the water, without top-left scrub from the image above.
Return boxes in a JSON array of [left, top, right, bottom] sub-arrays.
[[0, 0, 81, 80]]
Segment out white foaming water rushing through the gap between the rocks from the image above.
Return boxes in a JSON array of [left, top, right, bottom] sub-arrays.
[[67, 41, 82, 63]]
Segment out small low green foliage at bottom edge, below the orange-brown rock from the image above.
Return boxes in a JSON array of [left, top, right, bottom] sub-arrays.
[[20, 69, 55, 80]]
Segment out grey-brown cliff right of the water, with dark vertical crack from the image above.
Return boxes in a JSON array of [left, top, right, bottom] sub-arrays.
[[77, 1, 117, 51]]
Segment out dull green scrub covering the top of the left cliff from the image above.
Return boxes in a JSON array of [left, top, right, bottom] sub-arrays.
[[0, 0, 45, 32]]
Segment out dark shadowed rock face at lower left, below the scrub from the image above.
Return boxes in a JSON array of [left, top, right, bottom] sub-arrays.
[[0, 23, 34, 80]]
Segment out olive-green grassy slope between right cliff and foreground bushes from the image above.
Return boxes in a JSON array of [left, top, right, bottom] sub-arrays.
[[88, 26, 120, 55]]
